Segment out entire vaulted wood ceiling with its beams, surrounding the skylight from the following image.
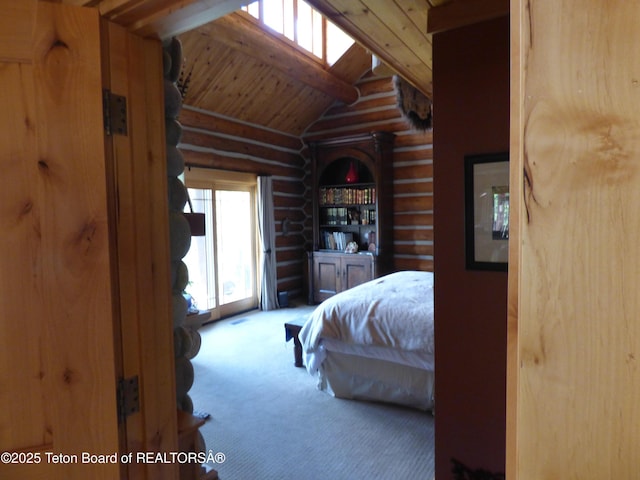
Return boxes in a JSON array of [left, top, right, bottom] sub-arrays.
[[72, 0, 509, 136]]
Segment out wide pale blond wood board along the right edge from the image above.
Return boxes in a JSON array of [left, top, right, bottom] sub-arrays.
[[506, 0, 640, 480]]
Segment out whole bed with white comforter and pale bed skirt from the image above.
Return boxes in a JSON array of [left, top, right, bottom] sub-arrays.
[[298, 271, 434, 410]]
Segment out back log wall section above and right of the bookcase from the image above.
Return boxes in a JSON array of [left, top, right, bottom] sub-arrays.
[[303, 74, 433, 271]]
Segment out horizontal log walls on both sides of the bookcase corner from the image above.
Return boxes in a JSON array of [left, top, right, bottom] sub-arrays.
[[179, 71, 433, 297]]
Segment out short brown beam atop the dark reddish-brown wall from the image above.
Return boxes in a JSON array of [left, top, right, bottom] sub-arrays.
[[427, 0, 509, 34]]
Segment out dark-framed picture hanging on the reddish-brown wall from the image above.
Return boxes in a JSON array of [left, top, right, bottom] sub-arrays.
[[464, 153, 509, 271]]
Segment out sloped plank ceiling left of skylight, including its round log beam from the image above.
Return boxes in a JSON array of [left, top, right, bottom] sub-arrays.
[[179, 12, 371, 136]]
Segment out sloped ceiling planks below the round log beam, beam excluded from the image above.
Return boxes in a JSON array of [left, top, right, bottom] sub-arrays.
[[180, 13, 340, 135]]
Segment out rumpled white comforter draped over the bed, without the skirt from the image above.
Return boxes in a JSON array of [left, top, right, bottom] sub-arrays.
[[299, 271, 434, 373]]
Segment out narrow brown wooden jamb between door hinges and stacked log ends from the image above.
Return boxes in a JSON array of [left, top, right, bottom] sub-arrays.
[[102, 17, 178, 480]]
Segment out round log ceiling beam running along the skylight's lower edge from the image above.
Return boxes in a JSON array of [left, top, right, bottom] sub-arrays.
[[199, 13, 360, 105]]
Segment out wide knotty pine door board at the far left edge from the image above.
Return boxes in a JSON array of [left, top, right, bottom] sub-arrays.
[[0, 0, 120, 480]]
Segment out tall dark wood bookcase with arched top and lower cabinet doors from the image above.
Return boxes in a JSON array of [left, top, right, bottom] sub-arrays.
[[309, 132, 395, 303]]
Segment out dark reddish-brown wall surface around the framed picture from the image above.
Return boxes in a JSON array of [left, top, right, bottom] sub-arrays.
[[433, 17, 509, 480]]
